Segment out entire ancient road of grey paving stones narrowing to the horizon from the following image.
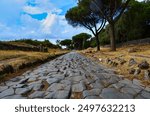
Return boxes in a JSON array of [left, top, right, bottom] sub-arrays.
[[0, 52, 150, 99]]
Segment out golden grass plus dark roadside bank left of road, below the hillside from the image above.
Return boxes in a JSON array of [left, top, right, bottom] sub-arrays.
[[0, 49, 68, 82]]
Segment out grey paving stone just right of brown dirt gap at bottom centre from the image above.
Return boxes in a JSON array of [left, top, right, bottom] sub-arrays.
[[83, 89, 101, 98]]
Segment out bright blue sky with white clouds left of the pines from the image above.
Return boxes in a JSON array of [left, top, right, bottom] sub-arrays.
[[0, 0, 144, 43]]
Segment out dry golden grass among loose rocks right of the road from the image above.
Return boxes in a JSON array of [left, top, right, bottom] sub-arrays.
[[81, 45, 150, 84]]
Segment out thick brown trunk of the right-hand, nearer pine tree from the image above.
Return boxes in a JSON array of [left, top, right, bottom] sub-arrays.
[[109, 23, 116, 51]]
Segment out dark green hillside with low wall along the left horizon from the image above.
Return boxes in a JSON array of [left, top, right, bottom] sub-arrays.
[[0, 39, 60, 52]]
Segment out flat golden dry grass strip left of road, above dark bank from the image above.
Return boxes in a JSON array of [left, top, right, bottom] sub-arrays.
[[0, 49, 66, 66]]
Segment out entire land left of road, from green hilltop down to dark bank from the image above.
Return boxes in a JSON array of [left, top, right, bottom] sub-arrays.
[[0, 40, 68, 82]]
